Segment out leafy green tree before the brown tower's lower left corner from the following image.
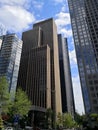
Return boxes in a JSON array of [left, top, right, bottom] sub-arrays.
[[9, 88, 32, 117]]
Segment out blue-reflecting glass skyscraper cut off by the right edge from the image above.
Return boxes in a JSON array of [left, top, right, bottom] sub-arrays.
[[68, 0, 98, 113]]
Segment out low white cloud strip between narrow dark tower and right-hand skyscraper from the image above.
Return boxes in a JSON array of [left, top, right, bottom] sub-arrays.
[[72, 75, 84, 114]]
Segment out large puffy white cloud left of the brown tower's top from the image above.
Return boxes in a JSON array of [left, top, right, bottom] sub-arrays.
[[0, 5, 35, 32]]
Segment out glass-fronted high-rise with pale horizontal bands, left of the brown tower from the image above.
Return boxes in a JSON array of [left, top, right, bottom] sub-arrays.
[[0, 34, 22, 94]]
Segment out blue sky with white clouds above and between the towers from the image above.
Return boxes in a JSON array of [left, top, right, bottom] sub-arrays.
[[0, 0, 84, 114]]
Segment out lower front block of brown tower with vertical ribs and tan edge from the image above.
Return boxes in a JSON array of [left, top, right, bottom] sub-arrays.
[[26, 45, 51, 110]]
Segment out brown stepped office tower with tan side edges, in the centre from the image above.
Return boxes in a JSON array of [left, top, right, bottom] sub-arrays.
[[18, 18, 62, 125]]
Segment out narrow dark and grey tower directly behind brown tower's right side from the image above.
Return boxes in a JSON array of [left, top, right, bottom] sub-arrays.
[[58, 34, 75, 115]]
